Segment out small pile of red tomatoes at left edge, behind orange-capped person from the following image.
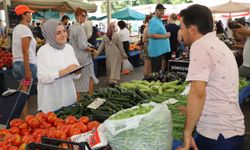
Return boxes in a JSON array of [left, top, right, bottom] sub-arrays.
[[0, 49, 12, 69]]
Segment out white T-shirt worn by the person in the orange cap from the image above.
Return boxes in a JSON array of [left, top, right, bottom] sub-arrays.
[[12, 24, 36, 64]]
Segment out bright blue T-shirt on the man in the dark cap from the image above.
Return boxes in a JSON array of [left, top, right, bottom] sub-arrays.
[[148, 16, 171, 57]]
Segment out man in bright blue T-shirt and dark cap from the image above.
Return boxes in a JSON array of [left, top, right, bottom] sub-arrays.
[[148, 4, 171, 72]]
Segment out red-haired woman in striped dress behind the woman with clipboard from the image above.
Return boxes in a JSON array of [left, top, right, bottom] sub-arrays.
[[69, 8, 98, 101]]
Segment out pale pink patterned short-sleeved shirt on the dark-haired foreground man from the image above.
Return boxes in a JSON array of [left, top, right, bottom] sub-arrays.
[[186, 32, 245, 140]]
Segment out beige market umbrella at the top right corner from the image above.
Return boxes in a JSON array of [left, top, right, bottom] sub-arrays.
[[210, 1, 250, 13]]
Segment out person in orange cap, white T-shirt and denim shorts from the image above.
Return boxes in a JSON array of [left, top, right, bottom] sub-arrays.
[[12, 5, 37, 117]]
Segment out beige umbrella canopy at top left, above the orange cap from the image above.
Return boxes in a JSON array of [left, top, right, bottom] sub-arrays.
[[1, 0, 97, 12]]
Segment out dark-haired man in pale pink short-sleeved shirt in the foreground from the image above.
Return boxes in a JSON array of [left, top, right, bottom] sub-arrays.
[[179, 4, 245, 150]]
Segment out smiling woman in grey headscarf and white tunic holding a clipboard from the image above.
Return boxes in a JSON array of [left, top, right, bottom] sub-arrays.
[[37, 19, 79, 112]]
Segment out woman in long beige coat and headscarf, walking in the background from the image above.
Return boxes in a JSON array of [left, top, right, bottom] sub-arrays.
[[95, 22, 128, 86]]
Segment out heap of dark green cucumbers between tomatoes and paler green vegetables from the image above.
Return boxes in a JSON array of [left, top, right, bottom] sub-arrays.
[[56, 87, 149, 122]]
